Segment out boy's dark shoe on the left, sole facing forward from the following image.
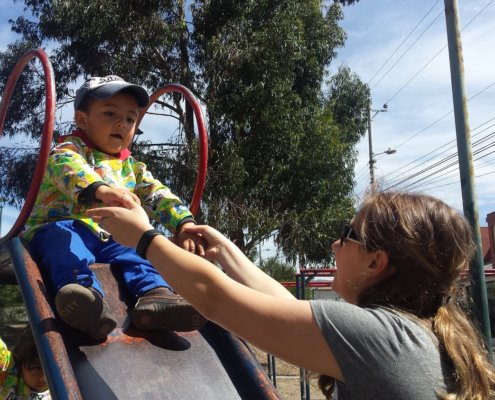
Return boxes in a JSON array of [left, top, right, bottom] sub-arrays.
[[55, 283, 117, 341]]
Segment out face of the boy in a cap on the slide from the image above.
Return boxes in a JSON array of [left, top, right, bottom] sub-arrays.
[[76, 93, 139, 154]]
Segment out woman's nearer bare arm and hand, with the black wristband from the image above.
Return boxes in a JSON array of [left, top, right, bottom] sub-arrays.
[[88, 201, 342, 380]]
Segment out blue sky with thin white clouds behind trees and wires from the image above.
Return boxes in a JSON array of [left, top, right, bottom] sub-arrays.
[[0, 0, 495, 235]]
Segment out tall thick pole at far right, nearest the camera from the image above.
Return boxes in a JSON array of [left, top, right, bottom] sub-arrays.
[[444, 0, 493, 359]]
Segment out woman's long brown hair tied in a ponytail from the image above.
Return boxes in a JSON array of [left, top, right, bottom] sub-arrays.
[[319, 192, 495, 400]]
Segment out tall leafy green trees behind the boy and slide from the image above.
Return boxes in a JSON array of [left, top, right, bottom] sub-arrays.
[[0, 0, 368, 263]]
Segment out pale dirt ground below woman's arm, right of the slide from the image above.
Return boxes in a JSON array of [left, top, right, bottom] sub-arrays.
[[251, 346, 325, 400]]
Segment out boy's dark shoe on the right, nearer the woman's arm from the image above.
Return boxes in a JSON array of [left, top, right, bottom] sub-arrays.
[[131, 287, 206, 332]]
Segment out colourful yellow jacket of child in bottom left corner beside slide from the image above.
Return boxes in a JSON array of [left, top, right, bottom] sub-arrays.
[[0, 339, 51, 400]]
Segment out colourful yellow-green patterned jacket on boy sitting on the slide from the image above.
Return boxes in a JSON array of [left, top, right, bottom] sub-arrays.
[[24, 131, 194, 240]]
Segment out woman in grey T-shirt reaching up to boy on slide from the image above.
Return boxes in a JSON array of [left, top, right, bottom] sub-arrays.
[[89, 192, 495, 400]]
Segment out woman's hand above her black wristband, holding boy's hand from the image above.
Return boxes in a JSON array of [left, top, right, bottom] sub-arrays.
[[86, 194, 153, 248]]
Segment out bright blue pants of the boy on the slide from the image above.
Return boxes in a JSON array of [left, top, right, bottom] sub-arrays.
[[29, 220, 170, 298]]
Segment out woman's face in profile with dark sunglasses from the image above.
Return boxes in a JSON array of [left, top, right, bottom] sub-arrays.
[[332, 224, 373, 304]]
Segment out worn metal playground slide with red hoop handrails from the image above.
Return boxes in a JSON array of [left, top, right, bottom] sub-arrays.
[[0, 49, 280, 400]]
